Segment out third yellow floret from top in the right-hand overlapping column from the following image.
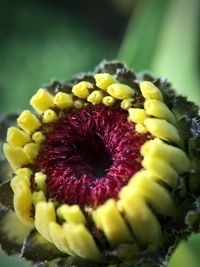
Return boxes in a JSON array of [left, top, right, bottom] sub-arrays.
[[144, 118, 181, 146]]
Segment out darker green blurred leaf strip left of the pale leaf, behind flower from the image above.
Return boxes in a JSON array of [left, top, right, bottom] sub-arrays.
[[118, 0, 168, 71]]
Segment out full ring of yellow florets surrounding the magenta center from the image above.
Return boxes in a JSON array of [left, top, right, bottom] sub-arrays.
[[4, 73, 190, 260]]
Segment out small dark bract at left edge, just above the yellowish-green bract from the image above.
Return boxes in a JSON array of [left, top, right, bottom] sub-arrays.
[[0, 181, 14, 210]]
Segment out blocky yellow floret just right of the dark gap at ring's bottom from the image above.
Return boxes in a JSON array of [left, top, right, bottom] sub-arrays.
[[93, 199, 133, 246]]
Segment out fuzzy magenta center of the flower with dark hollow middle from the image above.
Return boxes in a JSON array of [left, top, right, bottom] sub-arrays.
[[36, 104, 148, 207]]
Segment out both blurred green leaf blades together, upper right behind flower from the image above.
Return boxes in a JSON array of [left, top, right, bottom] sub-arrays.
[[118, 0, 200, 104]]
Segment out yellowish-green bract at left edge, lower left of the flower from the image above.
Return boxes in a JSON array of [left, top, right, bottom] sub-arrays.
[[0, 206, 30, 255]]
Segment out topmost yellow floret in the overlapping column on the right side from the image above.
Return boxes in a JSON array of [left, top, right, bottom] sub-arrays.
[[140, 81, 163, 101]]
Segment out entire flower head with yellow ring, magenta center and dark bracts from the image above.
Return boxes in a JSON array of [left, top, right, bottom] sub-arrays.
[[0, 62, 200, 266]]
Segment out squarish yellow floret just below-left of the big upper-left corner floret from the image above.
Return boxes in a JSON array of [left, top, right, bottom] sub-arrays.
[[17, 110, 40, 133]]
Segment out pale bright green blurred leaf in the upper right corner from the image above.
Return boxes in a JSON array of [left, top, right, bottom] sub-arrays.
[[150, 0, 200, 104]]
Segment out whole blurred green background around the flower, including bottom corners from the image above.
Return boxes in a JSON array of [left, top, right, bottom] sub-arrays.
[[0, 0, 200, 267]]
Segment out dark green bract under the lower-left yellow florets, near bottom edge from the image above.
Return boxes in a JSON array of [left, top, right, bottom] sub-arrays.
[[21, 229, 66, 263]]
